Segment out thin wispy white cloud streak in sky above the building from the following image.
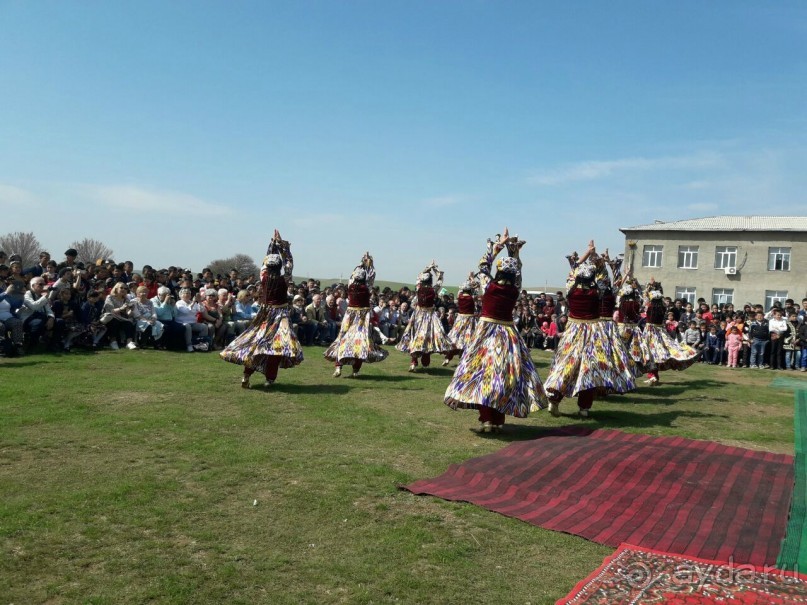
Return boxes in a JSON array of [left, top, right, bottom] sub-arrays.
[[528, 152, 724, 186]]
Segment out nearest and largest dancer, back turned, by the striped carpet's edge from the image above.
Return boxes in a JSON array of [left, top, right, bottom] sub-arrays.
[[444, 228, 547, 432]]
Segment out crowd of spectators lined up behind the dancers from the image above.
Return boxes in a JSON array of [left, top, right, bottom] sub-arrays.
[[0, 249, 807, 371]]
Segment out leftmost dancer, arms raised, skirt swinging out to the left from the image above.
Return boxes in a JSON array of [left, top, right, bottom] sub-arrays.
[[220, 229, 303, 389]]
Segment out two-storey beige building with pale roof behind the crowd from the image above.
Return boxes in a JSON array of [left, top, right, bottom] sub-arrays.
[[620, 216, 807, 309]]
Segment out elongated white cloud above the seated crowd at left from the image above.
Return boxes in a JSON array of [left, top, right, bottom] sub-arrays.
[[83, 185, 232, 216]]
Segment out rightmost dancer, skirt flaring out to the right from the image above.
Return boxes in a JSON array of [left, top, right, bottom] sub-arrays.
[[643, 277, 698, 386]]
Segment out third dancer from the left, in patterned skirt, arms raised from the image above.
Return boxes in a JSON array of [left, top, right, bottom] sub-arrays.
[[396, 261, 457, 372]]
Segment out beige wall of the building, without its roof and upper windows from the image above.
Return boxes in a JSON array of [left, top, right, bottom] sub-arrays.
[[622, 229, 807, 307]]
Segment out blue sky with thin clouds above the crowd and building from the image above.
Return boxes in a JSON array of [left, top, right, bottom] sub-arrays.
[[0, 0, 807, 286]]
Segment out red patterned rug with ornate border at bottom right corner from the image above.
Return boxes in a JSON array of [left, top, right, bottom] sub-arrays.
[[556, 544, 807, 605]]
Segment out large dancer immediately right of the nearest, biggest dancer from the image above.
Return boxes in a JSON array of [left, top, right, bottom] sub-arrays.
[[544, 240, 636, 418]]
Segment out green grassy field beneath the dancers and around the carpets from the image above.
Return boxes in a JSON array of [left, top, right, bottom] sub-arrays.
[[0, 347, 807, 605]]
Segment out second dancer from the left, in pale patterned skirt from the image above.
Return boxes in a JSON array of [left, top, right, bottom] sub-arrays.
[[325, 252, 389, 378]]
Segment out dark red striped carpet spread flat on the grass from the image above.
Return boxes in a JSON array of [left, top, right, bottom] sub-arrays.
[[405, 427, 793, 565]]
